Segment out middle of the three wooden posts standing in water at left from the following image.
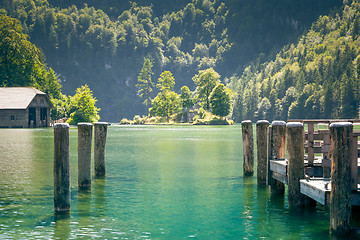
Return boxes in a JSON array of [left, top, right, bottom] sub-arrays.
[[78, 123, 93, 190]]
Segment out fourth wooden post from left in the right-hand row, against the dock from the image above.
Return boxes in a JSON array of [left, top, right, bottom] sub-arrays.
[[286, 122, 305, 207]]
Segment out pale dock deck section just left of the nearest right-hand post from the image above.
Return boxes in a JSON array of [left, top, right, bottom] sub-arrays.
[[300, 179, 331, 205]]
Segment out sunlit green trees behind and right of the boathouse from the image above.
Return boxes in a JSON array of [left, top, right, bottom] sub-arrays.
[[0, 13, 100, 124]]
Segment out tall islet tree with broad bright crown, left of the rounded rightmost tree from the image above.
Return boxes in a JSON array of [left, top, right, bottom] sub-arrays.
[[193, 68, 220, 110]]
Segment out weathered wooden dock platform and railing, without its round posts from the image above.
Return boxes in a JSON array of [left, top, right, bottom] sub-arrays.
[[270, 120, 360, 206]]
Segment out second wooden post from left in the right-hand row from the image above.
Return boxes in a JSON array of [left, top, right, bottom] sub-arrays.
[[256, 120, 269, 184]]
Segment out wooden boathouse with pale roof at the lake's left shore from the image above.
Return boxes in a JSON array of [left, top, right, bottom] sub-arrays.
[[0, 87, 52, 128]]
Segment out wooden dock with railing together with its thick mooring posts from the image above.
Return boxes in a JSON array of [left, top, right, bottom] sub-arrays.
[[246, 119, 360, 234]]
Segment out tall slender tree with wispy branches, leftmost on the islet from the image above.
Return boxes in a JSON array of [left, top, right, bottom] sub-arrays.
[[136, 58, 154, 107]]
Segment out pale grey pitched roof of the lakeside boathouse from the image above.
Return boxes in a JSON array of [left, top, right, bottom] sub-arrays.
[[0, 87, 46, 109]]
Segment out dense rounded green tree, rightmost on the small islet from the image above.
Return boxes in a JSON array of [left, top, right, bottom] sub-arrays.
[[209, 83, 232, 117]]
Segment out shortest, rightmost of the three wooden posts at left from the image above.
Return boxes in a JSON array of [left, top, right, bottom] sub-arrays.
[[94, 122, 108, 177]]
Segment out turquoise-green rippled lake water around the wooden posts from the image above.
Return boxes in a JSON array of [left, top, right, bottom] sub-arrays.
[[0, 125, 359, 239]]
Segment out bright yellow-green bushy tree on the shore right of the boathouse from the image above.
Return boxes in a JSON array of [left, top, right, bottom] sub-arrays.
[[67, 85, 100, 125]]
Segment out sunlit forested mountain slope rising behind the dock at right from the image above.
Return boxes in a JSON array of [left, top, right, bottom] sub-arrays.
[[229, 1, 360, 121]]
